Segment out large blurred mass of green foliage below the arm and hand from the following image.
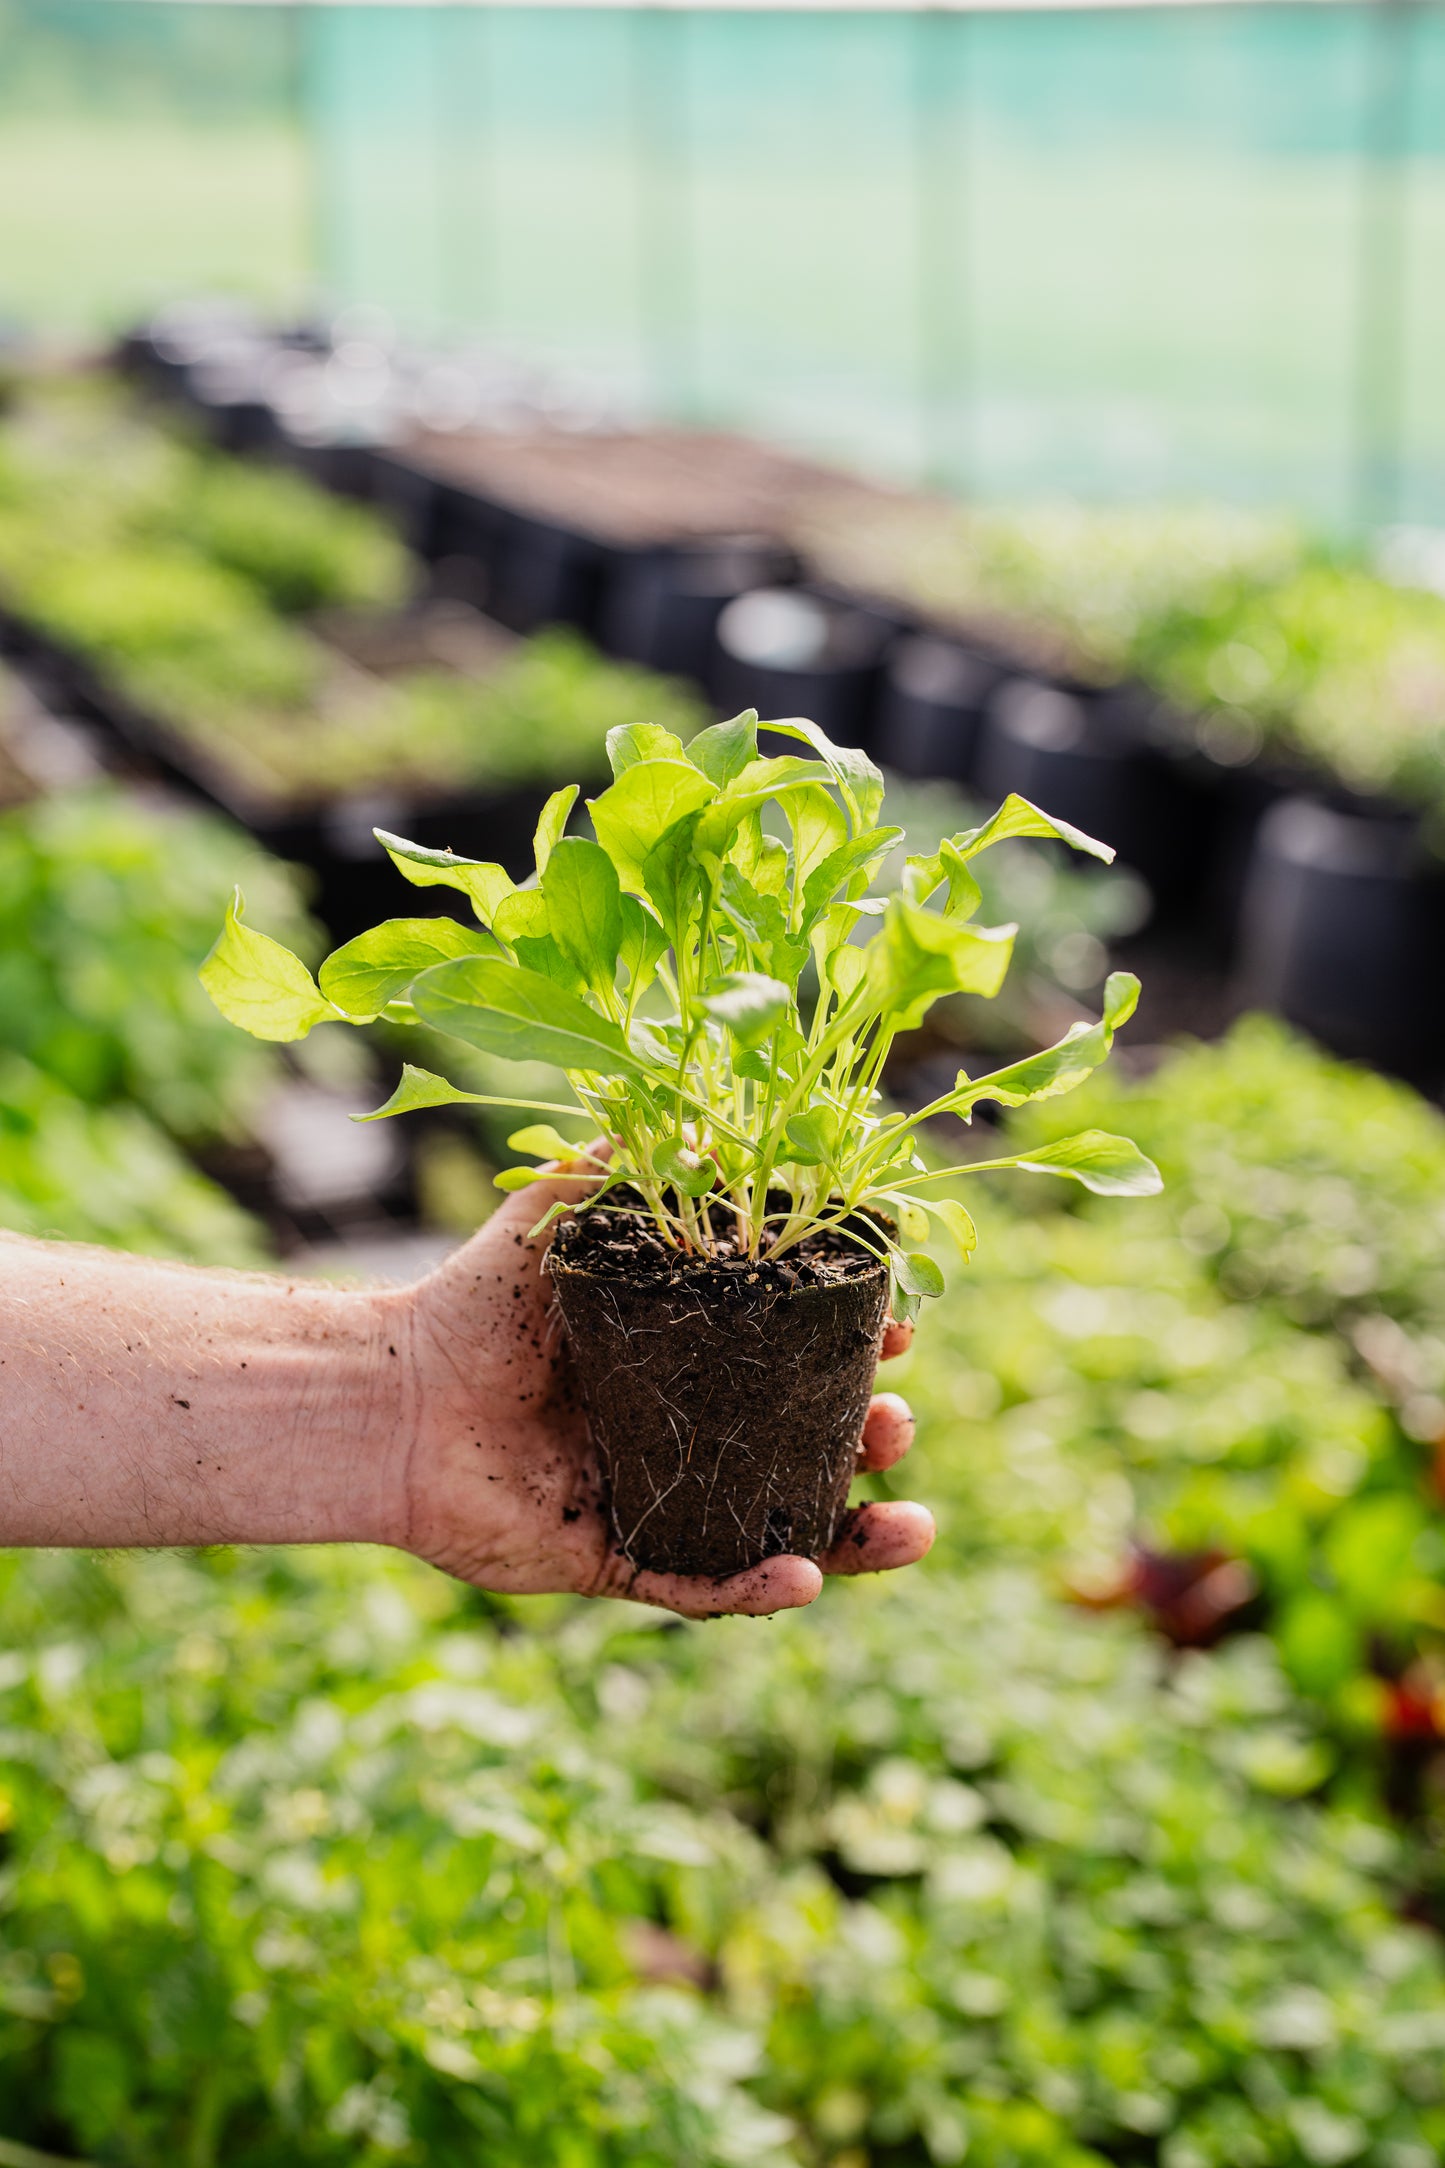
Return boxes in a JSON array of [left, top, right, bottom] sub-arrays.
[[0, 1552, 1445, 2168]]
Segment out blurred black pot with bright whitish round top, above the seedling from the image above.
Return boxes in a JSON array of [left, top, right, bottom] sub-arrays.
[[708, 588, 895, 748]]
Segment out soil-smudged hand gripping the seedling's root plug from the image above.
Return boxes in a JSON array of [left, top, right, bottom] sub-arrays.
[[387, 1179, 934, 1617]]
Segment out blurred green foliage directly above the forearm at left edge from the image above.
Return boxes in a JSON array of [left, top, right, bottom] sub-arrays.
[[0, 785, 316, 1264]]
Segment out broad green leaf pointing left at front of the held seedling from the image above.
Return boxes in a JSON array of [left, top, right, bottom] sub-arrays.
[[412, 956, 646, 1077]]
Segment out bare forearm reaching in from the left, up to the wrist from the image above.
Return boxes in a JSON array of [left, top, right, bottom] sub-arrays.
[[0, 1236, 412, 1548]]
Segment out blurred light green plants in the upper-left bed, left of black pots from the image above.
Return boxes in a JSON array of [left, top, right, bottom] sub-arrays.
[[0, 379, 708, 802]]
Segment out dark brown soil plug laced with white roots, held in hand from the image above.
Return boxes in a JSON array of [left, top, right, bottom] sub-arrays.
[[548, 1208, 888, 1578]]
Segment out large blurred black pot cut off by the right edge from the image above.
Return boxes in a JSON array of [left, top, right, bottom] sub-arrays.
[[1239, 798, 1445, 1082]]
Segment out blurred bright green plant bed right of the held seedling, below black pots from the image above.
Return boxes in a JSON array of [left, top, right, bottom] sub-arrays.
[[971, 1019, 1445, 1743]]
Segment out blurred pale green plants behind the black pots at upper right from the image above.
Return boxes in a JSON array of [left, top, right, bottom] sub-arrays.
[[810, 501, 1445, 813]]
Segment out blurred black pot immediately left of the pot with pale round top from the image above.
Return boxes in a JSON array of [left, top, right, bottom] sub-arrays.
[[598, 535, 797, 683]]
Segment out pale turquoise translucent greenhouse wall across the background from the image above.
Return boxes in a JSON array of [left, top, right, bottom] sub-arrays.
[[0, 0, 1445, 525]]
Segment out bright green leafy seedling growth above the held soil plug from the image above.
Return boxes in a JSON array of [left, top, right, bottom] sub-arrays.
[[201, 711, 1159, 1314]]
